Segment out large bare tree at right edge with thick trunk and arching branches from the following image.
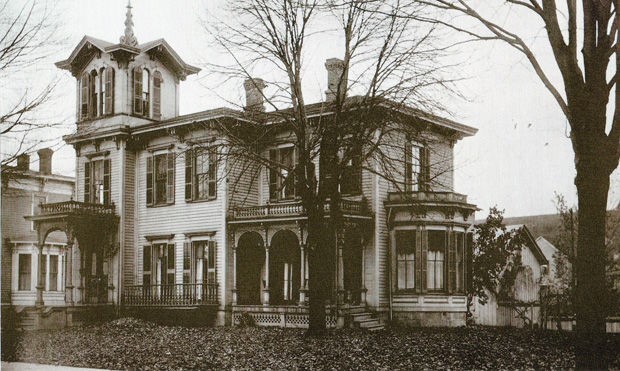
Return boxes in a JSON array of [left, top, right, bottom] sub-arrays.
[[402, 0, 620, 368]]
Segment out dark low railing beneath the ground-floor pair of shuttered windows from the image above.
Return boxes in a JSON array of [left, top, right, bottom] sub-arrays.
[[122, 283, 218, 307]]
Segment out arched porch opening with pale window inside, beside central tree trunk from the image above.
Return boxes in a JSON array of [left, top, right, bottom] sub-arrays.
[[269, 230, 301, 305]]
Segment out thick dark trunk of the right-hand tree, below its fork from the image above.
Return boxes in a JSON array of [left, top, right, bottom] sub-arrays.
[[575, 155, 609, 369]]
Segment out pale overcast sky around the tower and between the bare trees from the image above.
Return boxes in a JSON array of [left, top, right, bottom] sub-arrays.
[[10, 0, 620, 218]]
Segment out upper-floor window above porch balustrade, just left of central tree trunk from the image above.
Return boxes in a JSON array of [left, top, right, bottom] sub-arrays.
[[269, 147, 296, 200]]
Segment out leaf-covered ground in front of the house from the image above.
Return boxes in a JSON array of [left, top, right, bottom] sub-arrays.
[[2, 318, 620, 370]]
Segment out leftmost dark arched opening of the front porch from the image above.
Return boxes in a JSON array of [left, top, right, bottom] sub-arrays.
[[236, 232, 265, 305]]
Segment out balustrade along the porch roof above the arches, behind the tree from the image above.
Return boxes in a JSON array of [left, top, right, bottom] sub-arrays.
[[233, 200, 366, 219]]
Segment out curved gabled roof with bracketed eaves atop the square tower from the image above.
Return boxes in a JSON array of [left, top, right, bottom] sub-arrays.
[[56, 36, 200, 80]]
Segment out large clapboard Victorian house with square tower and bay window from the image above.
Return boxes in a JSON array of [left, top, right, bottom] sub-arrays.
[[23, 3, 476, 328]]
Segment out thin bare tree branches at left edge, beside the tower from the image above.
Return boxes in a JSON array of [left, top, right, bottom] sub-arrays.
[[0, 0, 63, 176]]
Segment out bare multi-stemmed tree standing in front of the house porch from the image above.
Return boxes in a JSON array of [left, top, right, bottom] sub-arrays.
[[201, 0, 452, 335]]
